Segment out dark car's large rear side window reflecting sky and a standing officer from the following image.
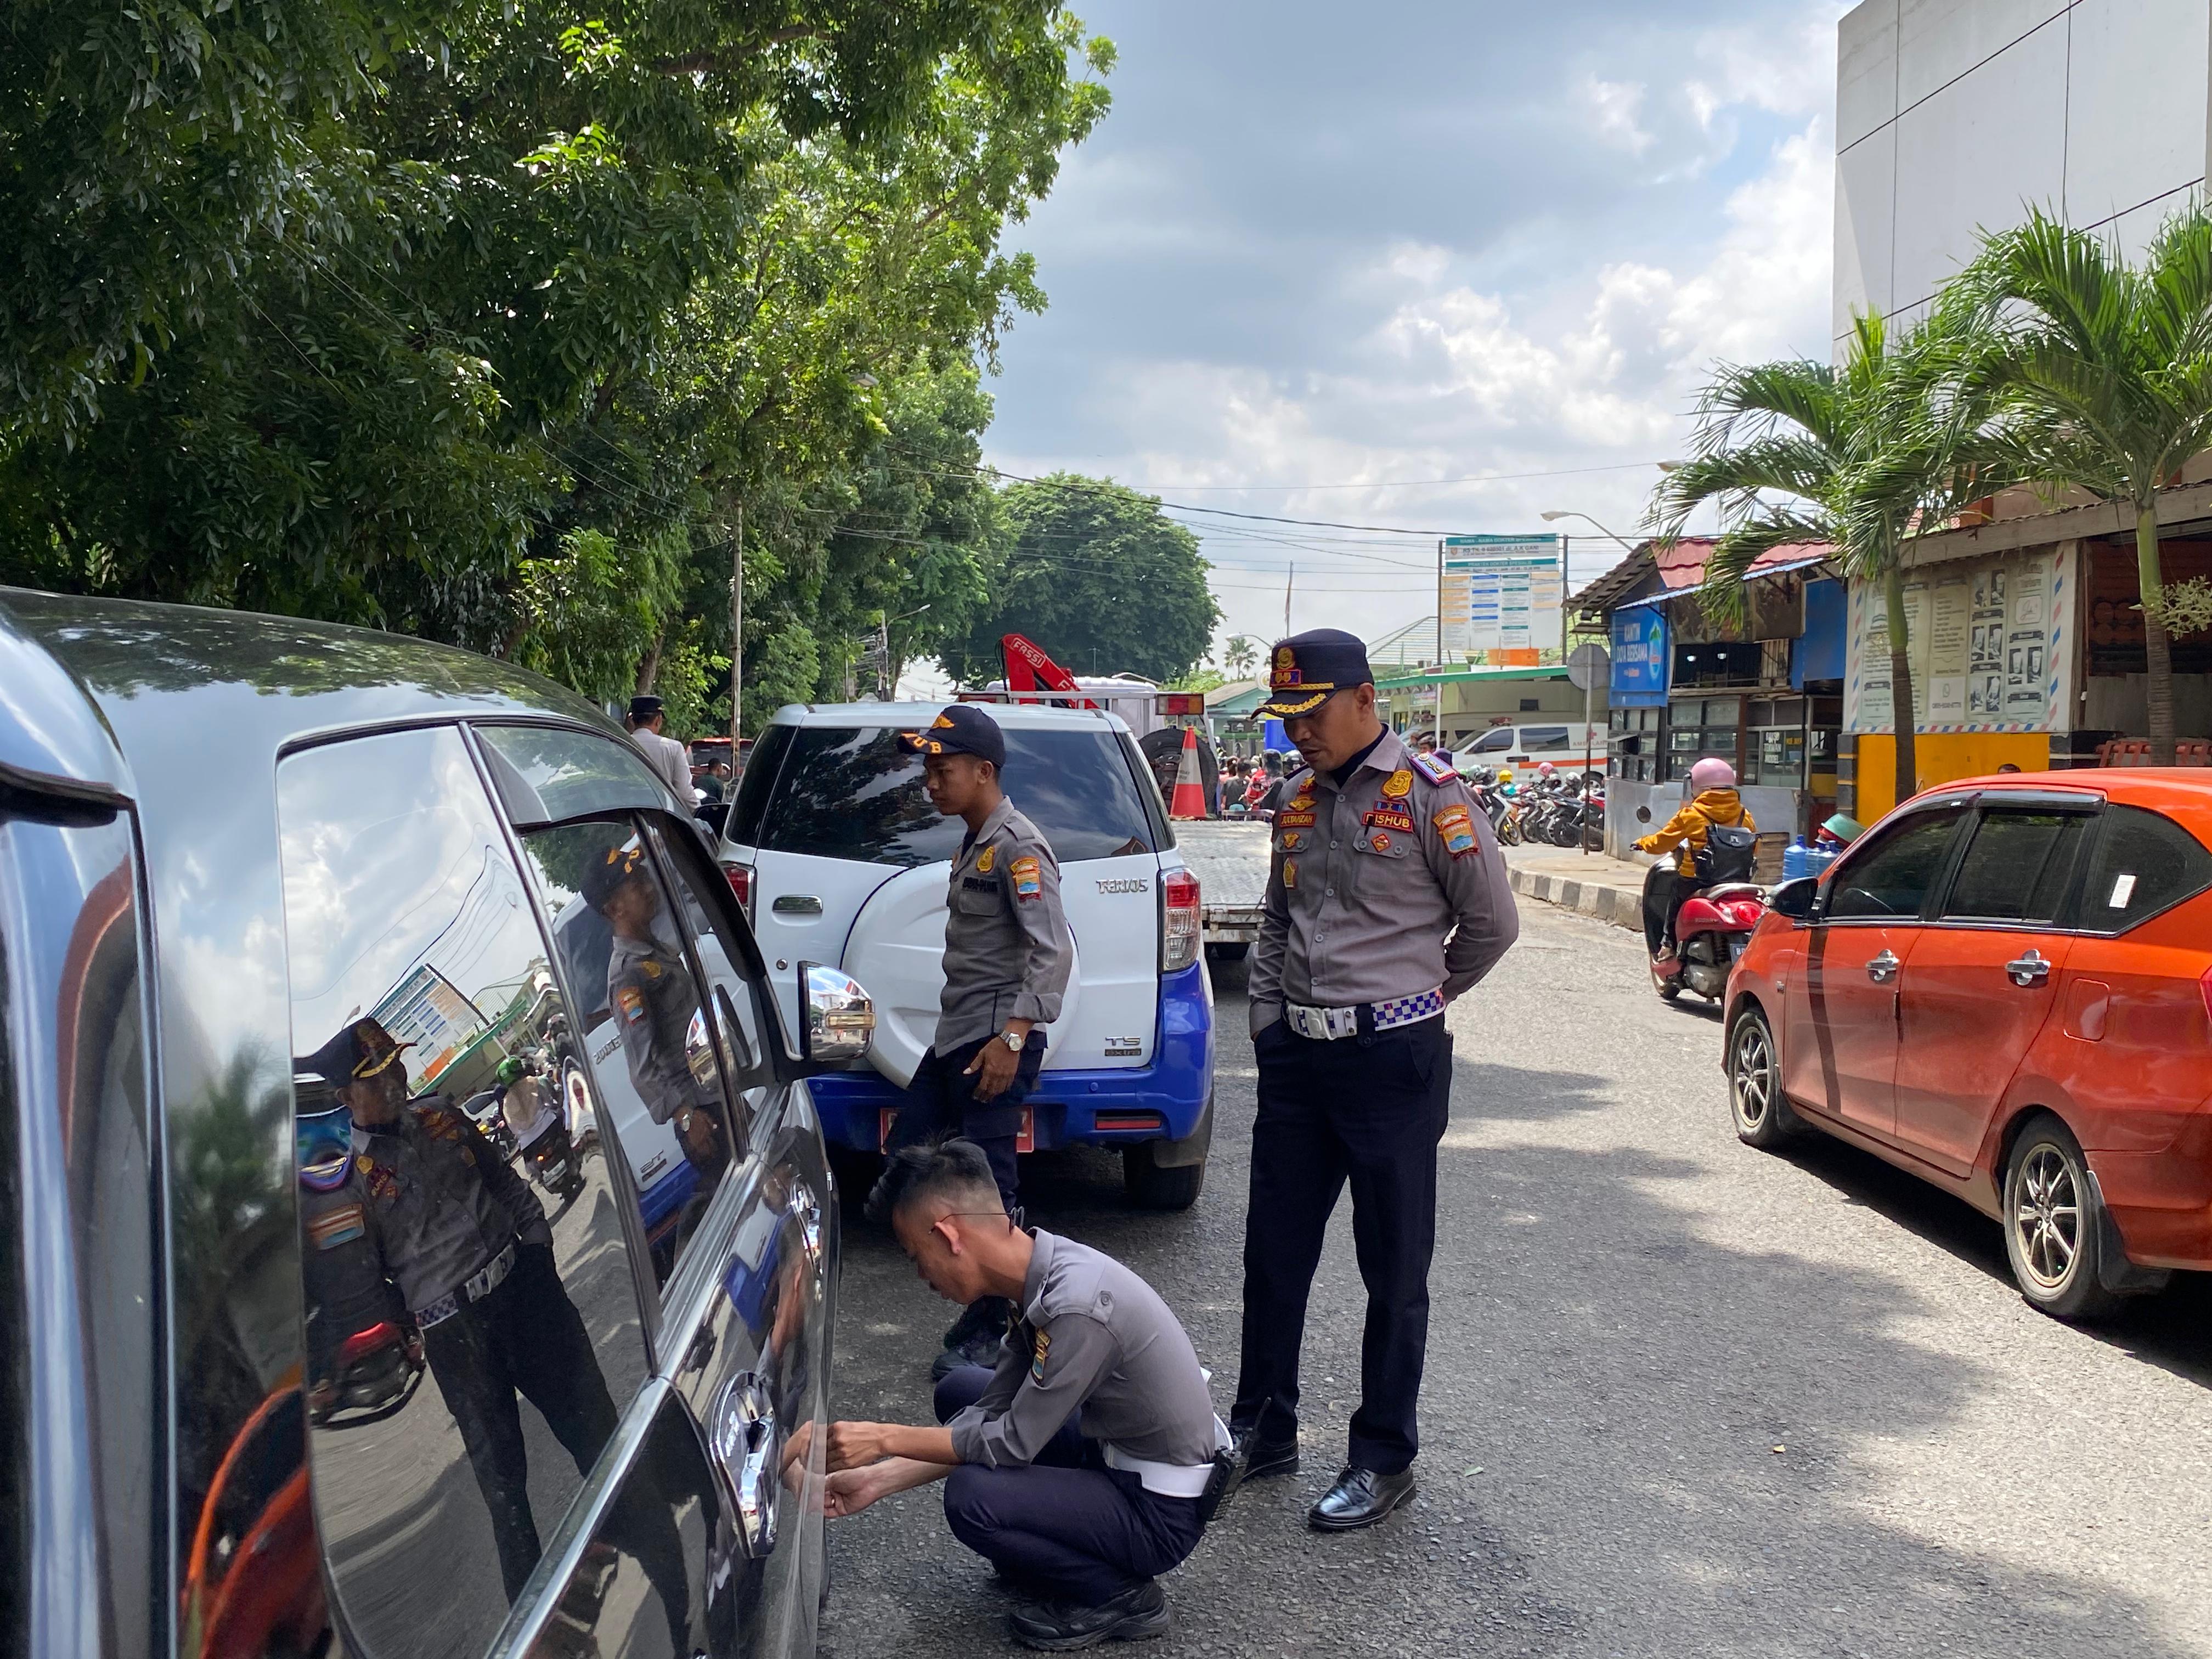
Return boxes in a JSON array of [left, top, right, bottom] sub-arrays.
[[276, 728, 646, 1659]]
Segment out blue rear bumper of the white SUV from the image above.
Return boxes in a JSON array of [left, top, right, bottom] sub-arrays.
[[808, 962, 1215, 1153]]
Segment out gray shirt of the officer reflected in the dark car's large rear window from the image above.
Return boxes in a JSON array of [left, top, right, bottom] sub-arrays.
[[341, 1095, 553, 1312]]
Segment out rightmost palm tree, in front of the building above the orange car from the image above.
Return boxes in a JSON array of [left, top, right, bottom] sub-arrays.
[[1960, 206, 2212, 761]]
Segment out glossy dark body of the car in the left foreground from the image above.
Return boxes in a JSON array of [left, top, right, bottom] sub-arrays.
[[0, 591, 836, 1659]]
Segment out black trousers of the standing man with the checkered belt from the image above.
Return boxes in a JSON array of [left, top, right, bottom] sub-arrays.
[[1230, 1020, 1451, 1475]]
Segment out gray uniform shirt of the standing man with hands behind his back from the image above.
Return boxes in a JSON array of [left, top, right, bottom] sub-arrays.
[[1250, 732, 1520, 1035]]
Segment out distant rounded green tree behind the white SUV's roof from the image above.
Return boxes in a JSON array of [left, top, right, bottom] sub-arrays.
[[943, 473, 1221, 686]]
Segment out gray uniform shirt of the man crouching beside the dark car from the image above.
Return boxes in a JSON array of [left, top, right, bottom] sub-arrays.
[[947, 1228, 1219, 1469]]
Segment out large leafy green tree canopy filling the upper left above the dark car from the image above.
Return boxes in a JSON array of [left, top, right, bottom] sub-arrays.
[[0, 0, 1110, 719]]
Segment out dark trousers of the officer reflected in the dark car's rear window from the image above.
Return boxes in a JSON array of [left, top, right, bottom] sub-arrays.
[[422, 1243, 690, 1652]]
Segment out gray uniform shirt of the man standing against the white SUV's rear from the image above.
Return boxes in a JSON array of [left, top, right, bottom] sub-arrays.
[[936, 801, 1075, 1053]]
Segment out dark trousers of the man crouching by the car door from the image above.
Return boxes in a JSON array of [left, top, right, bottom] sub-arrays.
[[936, 1365, 1205, 1608]]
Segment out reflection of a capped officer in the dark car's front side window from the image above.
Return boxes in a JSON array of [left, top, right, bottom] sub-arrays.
[[584, 843, 728, 1192]]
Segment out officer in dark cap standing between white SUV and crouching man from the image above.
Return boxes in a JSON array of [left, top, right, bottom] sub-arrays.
[[885, 703, 1075, 1376]]
